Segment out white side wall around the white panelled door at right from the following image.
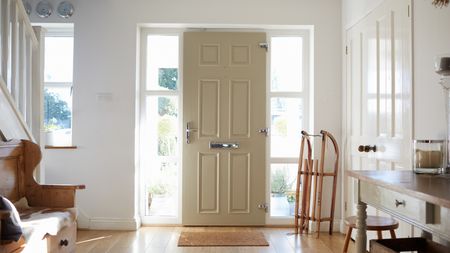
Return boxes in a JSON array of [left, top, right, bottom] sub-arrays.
[[342, 0, 450, 139]]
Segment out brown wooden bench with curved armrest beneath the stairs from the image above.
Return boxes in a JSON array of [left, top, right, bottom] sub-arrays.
[[0, 140, 85, 253]]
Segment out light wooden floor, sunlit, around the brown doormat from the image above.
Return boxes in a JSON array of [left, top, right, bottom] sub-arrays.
[[76, 227, 354, 253]]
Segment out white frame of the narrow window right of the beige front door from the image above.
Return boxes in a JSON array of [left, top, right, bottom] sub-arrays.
[[266, 28, 313, 225]]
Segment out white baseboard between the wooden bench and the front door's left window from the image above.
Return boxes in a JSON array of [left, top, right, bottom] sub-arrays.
[[78, 210, 141, 230]]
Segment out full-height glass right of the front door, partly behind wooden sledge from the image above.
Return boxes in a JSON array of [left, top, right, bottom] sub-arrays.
[[267, 35, 308, 220]]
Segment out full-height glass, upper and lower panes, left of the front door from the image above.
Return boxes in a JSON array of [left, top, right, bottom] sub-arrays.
[[139, 34, 181, 224]]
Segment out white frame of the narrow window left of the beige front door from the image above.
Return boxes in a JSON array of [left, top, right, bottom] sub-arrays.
[[136, 27, 183, 225]]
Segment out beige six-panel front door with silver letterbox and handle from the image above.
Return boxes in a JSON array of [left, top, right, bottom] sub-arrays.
[[182, 32, 266, 225]]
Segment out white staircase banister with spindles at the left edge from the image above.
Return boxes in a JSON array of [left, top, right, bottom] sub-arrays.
[[0, 0, 44, 143]]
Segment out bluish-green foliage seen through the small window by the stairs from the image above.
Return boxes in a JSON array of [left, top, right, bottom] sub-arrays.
[[44, 89, 72, 131]]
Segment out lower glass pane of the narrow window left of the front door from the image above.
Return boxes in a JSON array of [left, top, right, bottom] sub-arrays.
[[143, 96, 179, 216]]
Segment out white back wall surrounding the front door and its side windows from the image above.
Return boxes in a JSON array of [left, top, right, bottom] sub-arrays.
[[31, 0, 342, 228]]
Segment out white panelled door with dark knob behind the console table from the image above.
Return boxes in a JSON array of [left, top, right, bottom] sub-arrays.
[[344, 0, 412, 237]]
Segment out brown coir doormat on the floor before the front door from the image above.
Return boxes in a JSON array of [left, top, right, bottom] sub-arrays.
[[178, 231, 269, 247]]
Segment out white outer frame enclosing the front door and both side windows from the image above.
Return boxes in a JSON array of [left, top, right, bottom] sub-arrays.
[[135, 23, 314, 225]]
